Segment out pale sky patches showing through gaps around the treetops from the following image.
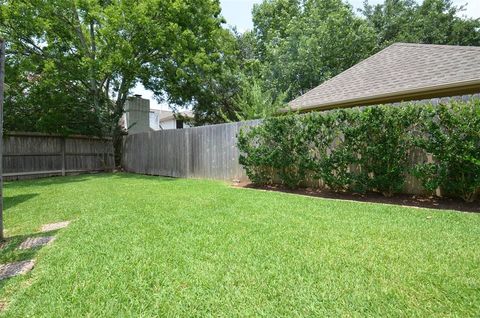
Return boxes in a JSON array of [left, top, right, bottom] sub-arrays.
[[132, 0, 480, 109]]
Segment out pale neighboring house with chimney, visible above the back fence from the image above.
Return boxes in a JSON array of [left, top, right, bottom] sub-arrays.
[[122, 95, 193, 135]]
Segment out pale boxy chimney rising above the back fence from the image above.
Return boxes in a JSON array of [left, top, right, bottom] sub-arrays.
[[125, 95, 150, 135]]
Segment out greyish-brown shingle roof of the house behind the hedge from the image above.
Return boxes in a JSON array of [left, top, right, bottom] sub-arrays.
[[289, 43, 480, 110]]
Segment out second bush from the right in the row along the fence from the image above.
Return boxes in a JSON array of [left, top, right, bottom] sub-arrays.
[[346, 106, 415, 196]]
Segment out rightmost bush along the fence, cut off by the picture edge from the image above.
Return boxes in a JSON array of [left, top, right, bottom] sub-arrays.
[[415, 100, 480, 202]]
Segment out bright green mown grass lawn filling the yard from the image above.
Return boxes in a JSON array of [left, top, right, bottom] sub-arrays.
[[0, 174, 480, 317]]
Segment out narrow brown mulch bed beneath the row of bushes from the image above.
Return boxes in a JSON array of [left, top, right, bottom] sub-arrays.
[[233, 183, 480, 213]]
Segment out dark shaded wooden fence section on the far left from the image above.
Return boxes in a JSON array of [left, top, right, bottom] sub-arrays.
[[3, 133, 115, 180]]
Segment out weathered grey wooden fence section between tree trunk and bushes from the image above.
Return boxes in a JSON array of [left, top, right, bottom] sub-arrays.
[[122, 120, 260, 180]]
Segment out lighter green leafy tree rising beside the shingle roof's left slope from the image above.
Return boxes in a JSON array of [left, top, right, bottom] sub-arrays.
[[253, 0, 375, 99]]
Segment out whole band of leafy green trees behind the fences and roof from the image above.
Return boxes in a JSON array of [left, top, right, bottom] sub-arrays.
[[0, 0, 480, 159]]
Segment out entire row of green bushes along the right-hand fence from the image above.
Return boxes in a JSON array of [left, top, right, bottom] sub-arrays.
[[238, 99, 480, 202]]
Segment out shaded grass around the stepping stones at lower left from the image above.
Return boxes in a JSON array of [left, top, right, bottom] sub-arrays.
[[0, 230, 59, 293]]
